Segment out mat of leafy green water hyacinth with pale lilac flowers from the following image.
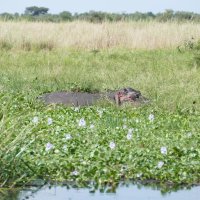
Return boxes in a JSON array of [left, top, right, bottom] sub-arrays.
[[0, 94, 200, 188]]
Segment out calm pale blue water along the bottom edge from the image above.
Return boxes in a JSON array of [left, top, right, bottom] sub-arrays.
[[0, 185, 200, 200]]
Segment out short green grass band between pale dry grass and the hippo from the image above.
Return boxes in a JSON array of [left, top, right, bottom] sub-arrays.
[[0, 49, 200, 111]]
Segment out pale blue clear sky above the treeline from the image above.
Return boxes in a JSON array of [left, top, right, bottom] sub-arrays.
[[0, 0, 200, 14]]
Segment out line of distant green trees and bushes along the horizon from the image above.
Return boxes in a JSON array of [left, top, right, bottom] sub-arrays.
[[0, 6, 200, 23]]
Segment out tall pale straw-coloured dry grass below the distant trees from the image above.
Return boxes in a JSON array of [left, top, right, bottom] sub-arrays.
[[0, 21, 200, 50]]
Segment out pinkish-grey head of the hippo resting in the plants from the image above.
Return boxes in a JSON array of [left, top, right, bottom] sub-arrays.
[[115, 88, 149, 105]]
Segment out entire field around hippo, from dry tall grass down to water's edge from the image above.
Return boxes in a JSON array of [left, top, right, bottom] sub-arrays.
[[0, 22, 200, 186]]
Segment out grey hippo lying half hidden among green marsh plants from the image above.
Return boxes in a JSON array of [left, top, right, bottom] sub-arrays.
[[38, 88, 149, 107]]
